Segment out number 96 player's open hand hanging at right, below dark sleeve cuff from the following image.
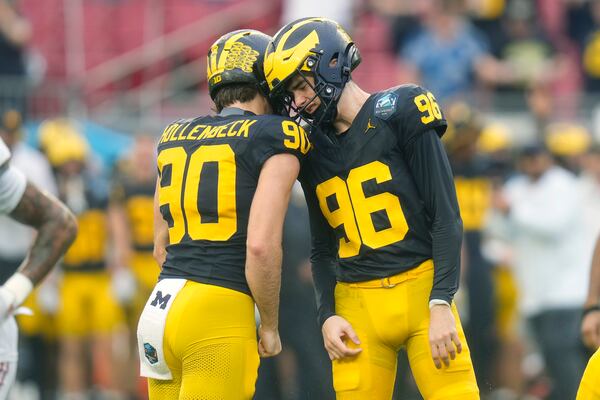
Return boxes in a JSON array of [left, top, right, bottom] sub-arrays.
[[429, 304, 462, 369]]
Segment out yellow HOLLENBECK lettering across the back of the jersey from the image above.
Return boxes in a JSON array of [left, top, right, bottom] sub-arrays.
[[159, 119, 256, 143]]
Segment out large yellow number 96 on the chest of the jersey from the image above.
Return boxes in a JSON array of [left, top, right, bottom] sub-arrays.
[[316, 161, 408, 258]]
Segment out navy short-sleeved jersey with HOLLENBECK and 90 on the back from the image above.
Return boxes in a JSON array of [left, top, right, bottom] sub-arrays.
[[157, 108, 311, 294]]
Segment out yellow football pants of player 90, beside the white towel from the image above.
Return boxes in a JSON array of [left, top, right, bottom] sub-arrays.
[[148, 281, 259, 400]]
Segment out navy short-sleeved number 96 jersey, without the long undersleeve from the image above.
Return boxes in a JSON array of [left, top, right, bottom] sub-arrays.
[[300, 85, 446, 282]]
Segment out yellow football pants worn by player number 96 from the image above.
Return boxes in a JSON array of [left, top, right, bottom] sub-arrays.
[[333, 261, 479, 400]]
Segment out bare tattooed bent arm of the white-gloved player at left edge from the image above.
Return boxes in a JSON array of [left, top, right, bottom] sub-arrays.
[[11, 183, 77, 285]]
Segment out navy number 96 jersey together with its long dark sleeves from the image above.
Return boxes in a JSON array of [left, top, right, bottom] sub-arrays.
[[300, 85, 461, 324]]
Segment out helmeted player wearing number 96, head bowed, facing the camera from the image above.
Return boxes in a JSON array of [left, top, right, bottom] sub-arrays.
[[264, 18, 479, 400]]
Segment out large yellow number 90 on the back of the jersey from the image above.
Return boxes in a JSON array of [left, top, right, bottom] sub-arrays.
[[158, 144, 237, 244]]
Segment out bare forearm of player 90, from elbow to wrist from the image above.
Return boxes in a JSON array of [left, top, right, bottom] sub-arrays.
[[246, 244, 281, 330]]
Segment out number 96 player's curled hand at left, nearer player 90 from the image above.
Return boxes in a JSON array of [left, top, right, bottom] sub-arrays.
[[321, 315, 362, 361]]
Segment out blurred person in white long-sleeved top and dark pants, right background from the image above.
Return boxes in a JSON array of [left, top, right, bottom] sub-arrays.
[[494, 145, 589, 400]]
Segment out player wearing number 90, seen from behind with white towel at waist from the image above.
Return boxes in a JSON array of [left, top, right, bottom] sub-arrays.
[[138, 30, 311, 400]]
